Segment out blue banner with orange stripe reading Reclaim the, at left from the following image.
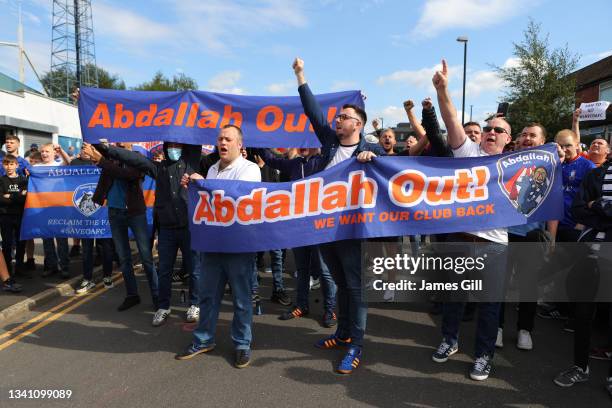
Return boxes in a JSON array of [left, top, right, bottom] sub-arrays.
[[21, 166, 155, 240]]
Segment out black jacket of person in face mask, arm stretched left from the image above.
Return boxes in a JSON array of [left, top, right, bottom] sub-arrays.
[[96, 143, 202, 228]]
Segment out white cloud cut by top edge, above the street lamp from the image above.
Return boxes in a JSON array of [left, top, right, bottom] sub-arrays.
[[412, 0, 537, 38]]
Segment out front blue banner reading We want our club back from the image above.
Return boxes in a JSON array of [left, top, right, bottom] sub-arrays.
[[189, 145, 563, 252]]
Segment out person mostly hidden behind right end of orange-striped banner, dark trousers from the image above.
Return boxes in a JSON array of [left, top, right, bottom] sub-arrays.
[[70, 150, 114, 294]]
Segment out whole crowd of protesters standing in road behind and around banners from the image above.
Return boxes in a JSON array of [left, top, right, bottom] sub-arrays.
[[0, 58, 612, 395]]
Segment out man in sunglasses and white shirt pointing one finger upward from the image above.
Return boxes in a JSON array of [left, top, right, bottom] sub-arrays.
[[432, 60, 511, 381]]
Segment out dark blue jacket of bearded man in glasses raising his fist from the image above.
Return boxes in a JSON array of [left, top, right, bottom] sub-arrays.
[[298, 84, 385, 173]]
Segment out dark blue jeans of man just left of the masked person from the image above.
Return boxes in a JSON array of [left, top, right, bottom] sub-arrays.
[[108, 208, 159, 305]]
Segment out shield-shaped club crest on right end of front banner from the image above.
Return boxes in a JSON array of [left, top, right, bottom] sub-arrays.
[[497, 149, 557, 217]]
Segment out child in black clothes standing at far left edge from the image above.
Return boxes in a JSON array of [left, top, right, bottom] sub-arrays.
[[0, 154, 28, 275]]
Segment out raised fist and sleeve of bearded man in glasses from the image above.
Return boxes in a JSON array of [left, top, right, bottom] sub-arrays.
[[292, 58, 338, 145]]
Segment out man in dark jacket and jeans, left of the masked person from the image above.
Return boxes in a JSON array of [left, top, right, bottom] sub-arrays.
[[82, 143, 159, 312]]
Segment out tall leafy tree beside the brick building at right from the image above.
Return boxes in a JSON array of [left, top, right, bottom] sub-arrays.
[[495, 20, 579, 137]]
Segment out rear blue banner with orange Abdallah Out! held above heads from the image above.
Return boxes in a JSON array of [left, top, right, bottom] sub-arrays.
[[79, 88, 364, 147]]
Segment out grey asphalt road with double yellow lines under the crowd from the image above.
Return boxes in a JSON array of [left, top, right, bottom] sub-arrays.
[[0, 274, 611, 407]]
